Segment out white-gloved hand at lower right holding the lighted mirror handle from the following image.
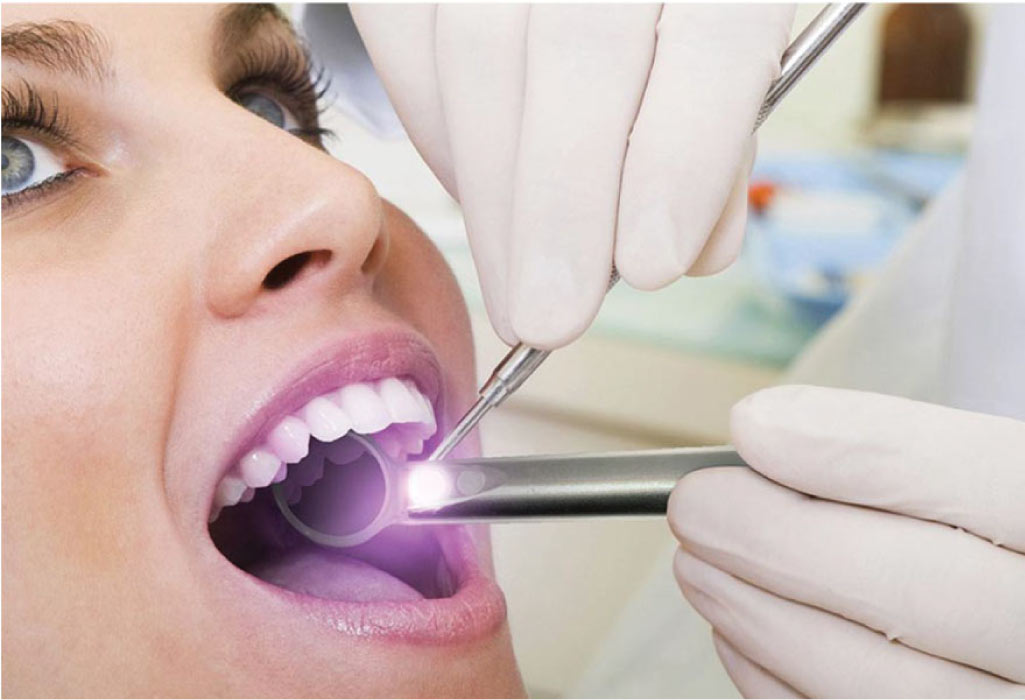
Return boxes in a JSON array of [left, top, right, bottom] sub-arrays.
[[669, 386, 1025, 697]]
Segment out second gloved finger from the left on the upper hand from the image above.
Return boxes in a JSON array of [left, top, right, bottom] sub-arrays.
[[436, 4, 529, 344]]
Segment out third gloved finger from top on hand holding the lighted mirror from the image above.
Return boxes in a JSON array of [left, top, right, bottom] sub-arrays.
[[673, 550, 1025, 697]]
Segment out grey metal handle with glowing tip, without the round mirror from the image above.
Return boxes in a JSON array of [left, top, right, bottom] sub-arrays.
[[404, 446, 747, 524]]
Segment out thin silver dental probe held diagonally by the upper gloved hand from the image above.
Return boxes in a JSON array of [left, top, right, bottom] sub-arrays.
[[428, 2, 865, 460]]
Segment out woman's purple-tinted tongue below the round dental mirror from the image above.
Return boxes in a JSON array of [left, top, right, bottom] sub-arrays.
[[249, 547, 423, 603]]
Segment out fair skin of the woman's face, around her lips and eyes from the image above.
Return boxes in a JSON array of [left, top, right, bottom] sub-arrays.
[[2, 5, 523, 696]]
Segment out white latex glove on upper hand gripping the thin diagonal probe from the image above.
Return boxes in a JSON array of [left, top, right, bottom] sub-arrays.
[[353, 4, 792, 348]]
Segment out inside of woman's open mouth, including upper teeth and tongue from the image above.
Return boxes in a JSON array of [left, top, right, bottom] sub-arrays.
[[209, 376, 460, 603]]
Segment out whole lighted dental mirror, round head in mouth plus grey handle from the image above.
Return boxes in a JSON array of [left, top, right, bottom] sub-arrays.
[[273, 434, 746, 547]]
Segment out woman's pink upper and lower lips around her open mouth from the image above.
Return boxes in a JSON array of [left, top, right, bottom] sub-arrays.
[[193, 329, 506, 645]]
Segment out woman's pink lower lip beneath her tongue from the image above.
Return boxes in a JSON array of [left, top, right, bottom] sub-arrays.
[[214, 526, 505, 646]]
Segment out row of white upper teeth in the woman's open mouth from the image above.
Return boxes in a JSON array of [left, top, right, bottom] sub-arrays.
[[210, 377, 438, 522]]
